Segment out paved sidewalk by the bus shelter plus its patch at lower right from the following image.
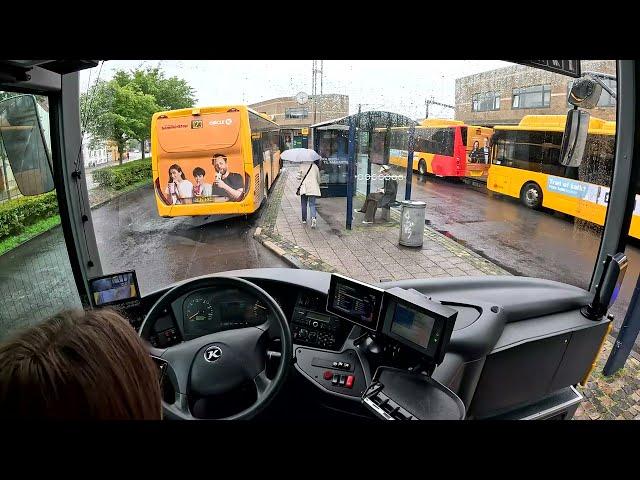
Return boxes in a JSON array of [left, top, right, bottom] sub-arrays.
[[254, 167, 640, 420]]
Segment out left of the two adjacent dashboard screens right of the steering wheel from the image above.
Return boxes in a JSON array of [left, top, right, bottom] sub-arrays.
[[327, 274, 384, 330]]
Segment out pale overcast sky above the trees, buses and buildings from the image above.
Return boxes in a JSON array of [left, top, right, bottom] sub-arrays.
[[80, 60, 509, 118]]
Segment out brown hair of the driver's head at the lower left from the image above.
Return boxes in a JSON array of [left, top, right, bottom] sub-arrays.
[[0, 309, 162, 420]]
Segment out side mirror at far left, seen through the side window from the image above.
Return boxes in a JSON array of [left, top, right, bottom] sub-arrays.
[[0, 95, 54, 195]]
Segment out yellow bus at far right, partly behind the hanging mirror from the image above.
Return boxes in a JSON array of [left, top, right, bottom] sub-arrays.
[[487, 115, 640, 238]]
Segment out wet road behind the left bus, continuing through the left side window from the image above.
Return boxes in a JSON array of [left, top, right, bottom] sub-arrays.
[[0, 186, 288, 339]]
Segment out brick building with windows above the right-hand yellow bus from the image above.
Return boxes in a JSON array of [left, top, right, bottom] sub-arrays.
[[455, 60, 616, 126]]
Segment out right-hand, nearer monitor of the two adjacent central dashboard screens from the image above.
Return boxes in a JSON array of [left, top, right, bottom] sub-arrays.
[[382, 287, 458, 364]]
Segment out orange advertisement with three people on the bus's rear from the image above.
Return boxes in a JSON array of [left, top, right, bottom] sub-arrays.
[[154, 112, 248, 205]]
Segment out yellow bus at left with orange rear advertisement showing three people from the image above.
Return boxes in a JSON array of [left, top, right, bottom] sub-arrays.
[[151, 105, 281, 217]]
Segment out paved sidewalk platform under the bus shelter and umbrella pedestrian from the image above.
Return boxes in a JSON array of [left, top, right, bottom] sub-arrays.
[[255, 170, 509, 283]]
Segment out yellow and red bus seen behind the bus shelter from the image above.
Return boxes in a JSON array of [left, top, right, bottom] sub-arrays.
[[389, 118, 493, 178]]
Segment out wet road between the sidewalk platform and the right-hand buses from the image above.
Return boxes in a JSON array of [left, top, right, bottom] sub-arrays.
[[398, 174, 640, 331]]
